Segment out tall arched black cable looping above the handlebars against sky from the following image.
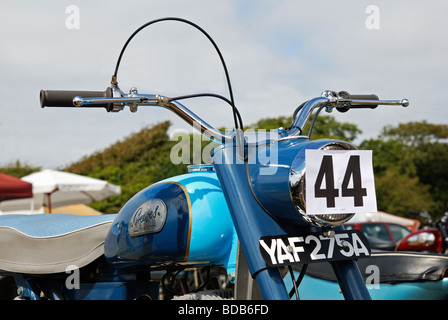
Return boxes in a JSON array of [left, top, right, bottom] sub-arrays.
[[111, 17, 243, 129]]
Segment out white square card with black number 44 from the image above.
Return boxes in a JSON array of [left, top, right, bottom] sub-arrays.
[[305, 150, 377, 214]]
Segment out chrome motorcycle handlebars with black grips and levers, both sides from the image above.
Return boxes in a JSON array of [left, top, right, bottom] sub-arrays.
[[40, 86, 409, 144]]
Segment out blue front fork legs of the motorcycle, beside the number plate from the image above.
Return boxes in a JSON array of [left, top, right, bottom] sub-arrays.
[[213, 146, 370, 300]]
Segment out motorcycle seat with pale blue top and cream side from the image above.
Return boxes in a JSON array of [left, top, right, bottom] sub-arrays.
[[0, 213, 116, 274]]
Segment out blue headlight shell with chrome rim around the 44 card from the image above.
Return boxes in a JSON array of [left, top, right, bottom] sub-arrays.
[[247, 137, 356, 227]]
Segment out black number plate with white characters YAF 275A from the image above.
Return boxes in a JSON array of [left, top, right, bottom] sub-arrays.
[[259, 230, 370, 267]]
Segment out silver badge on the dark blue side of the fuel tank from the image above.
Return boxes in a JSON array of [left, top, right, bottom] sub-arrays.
[[128, 199, 167, 237]]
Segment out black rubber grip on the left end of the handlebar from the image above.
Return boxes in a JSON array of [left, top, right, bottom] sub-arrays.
[[40, 87, 113, 111]]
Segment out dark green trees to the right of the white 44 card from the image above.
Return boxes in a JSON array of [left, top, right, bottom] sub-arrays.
[[360, 121, 448, 216]]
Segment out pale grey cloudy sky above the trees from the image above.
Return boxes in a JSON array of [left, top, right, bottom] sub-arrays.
[[0, 0, 448, 168]]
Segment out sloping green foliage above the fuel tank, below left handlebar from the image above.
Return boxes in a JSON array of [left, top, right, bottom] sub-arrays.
[[65, 122, 187, 213]]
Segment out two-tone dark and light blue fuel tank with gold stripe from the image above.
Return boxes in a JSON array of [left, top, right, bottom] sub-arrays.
[[104, 165, 237, 273]]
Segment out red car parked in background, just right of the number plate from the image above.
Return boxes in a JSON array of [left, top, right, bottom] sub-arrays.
[[344, 222, 411, 244]]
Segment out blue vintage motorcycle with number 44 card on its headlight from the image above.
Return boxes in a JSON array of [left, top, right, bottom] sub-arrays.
[[0, 17, 409, 300]]
